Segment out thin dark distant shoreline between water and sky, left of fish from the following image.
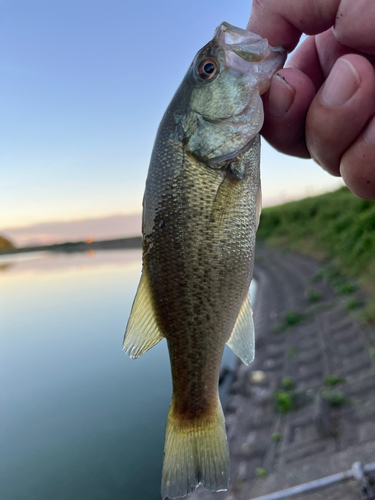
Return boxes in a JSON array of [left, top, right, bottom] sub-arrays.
[[0, 236, 142, 257]]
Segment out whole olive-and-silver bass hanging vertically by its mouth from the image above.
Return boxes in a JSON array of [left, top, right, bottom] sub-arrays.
[[123, 22, 286, 499]]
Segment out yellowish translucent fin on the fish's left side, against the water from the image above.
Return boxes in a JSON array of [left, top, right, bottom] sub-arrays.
[[122, 271, 163, 359]]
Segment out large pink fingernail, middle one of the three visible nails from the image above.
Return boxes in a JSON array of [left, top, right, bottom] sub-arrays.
[[322, 58, 360, 106]]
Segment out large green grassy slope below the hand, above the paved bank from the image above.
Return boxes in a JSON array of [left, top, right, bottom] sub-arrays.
[[258, 188, 375, 322]]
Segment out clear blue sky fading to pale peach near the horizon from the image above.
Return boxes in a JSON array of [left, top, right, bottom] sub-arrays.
[[0, 0, 341, 244]]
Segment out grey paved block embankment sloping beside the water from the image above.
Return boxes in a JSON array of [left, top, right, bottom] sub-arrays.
[[190, 246, 375, 500]]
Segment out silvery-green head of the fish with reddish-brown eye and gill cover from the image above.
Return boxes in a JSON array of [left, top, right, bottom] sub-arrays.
[[175, 23, 286, 166]]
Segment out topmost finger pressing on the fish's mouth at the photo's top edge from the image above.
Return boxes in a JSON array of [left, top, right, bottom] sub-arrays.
[[247, 0, 340, 52]]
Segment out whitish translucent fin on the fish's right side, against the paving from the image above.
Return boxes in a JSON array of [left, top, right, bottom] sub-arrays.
[[227, 292, 255, 365]]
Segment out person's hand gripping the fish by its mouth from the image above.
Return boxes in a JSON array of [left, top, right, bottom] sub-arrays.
[[247, 0, 375, 199]]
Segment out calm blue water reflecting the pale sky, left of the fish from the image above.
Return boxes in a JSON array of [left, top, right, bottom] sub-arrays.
[[0, 250, 256, 500]]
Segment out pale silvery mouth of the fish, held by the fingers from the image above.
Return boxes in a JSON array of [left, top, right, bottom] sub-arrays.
[[214, 22, 287, 87]]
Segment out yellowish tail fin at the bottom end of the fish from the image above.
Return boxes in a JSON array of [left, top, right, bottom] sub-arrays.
[[161, 399, 229, 499]]
